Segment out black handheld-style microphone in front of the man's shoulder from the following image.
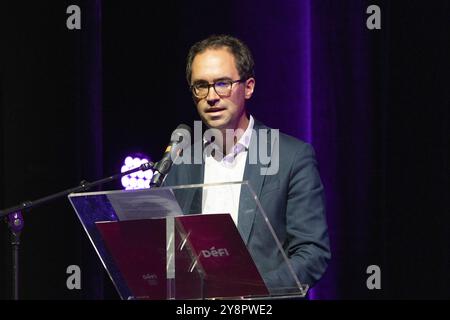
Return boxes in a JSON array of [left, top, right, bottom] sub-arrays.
[[150, 124, 191, 188]]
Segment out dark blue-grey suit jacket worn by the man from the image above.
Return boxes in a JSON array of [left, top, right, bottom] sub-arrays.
[[164, 121, 331, 289]]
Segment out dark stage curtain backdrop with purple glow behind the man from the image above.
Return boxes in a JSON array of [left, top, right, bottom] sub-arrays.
[[0, 0, 450, 299]]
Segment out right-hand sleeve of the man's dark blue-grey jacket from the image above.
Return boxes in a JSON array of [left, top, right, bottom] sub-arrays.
[[265, 143, 331, 287]]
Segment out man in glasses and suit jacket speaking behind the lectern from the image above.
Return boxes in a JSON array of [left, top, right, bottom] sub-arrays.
[[164, 35, 331, 287]]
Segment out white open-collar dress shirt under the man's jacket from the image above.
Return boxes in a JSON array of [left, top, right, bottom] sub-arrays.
[[202, 116, 254, 225]]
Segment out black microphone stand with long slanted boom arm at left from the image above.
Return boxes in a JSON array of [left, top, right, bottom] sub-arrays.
[[0, 162, 155, 300]]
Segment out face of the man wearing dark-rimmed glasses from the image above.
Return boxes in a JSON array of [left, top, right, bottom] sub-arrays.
[[191, 48, 255, 129]]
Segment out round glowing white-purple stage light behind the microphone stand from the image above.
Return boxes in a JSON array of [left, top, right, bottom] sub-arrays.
[[120, 156, 153, 190]]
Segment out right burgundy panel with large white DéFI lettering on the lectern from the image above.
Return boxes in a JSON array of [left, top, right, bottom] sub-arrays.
[[175, 214, 268, 299]]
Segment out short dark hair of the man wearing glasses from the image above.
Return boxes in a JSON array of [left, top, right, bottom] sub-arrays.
[[186, 34, 255, 84]]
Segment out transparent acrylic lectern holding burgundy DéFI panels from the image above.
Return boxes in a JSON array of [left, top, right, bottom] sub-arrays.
[[69, 182, 308, 300]]
